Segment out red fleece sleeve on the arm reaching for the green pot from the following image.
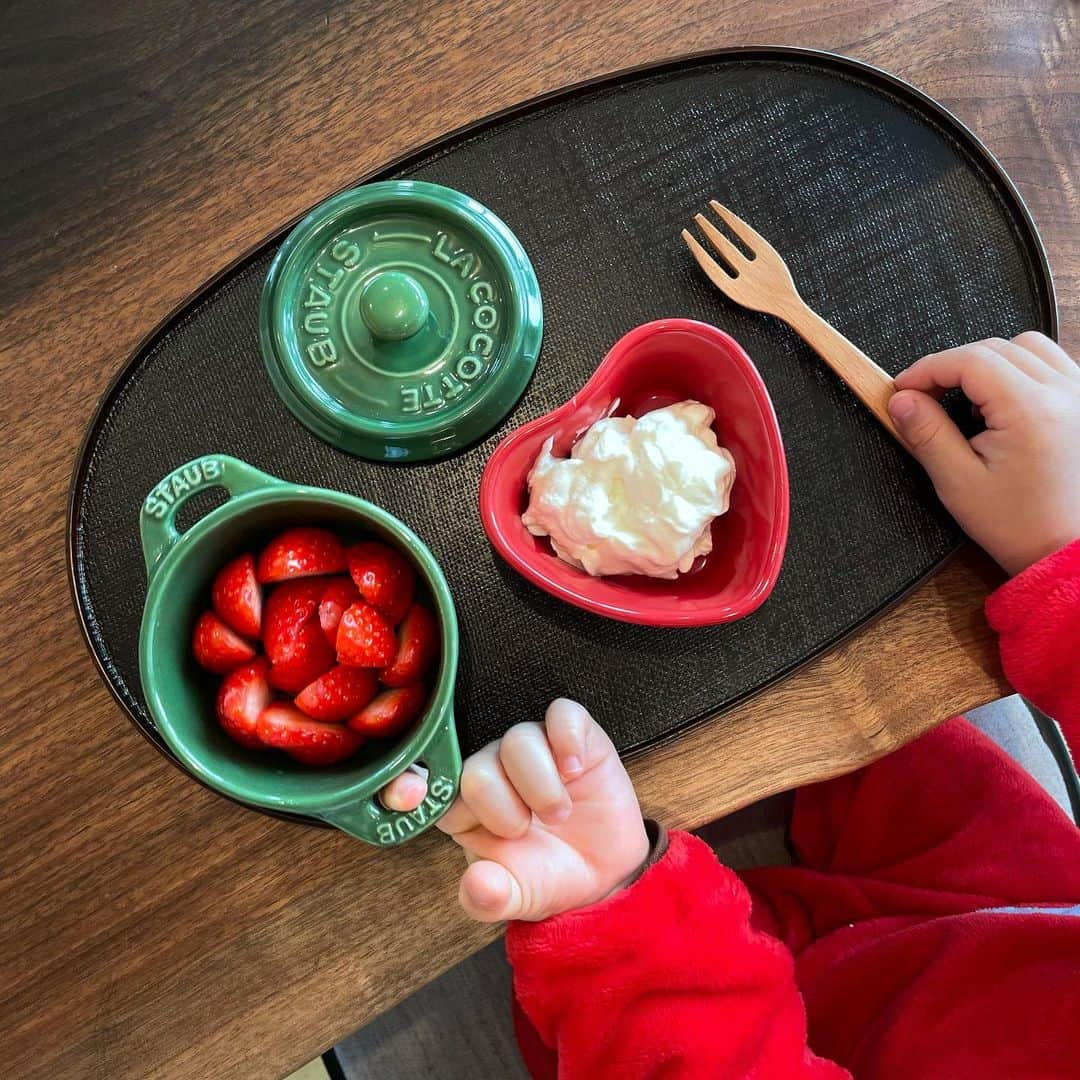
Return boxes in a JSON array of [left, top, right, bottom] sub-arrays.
[[507, 833, 848, 1080]]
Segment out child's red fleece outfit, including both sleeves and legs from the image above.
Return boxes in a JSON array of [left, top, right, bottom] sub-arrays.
[[507, 541, 1080, 1080]]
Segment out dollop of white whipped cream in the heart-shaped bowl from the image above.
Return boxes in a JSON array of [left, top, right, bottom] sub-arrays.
[[522, 401, 735, 578]]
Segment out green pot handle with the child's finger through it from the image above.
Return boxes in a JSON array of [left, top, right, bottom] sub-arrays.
[[320, 710, 461, 848]]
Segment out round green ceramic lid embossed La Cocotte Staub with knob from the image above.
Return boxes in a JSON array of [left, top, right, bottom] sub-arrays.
[[259, 180, 543, 461]]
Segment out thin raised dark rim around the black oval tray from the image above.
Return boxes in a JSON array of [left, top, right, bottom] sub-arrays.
[[65, 44, 1059, 828]]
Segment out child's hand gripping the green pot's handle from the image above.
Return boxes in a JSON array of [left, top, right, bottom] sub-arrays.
[[423, 699, 649, 922]]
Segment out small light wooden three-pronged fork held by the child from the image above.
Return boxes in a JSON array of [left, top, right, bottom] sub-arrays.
[[683, 199, 900, 440]]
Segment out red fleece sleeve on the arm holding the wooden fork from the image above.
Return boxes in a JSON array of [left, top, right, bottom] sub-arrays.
[[986, 540, 1080, 759]]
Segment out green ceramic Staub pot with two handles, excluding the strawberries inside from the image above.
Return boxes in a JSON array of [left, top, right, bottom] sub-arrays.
[[139, 455, 461, 846]]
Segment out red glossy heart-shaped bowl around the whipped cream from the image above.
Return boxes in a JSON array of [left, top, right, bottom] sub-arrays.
[[480, 319, 788, 626]]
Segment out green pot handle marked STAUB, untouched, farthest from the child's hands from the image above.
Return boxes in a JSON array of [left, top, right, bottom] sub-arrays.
[[139, 454, 285, 578]]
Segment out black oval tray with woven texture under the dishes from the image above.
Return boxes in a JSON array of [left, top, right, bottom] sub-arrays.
[[69, 48, 1056, 825]]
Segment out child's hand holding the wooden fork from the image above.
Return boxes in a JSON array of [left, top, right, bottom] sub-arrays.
[[889, 332, 1080, 573]]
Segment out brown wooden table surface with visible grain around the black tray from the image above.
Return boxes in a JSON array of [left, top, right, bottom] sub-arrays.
[[0, 0, 1080, 1080]]
